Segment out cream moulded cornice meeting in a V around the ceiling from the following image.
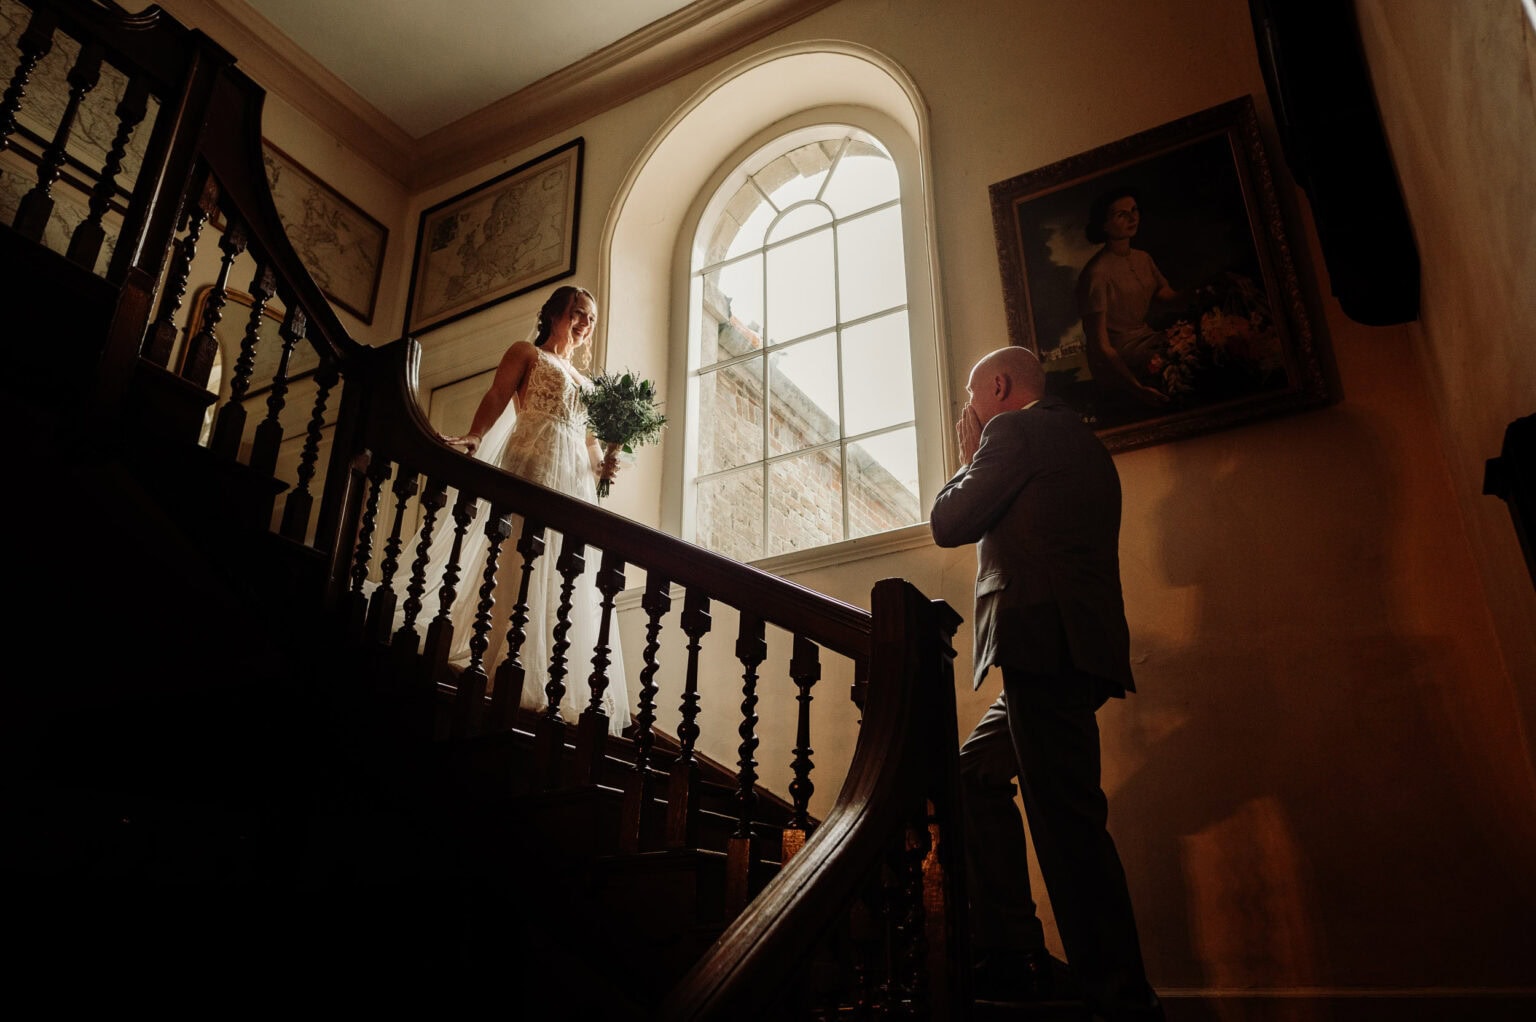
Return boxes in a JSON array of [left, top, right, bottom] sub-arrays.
[[160, 0, 837, 192]]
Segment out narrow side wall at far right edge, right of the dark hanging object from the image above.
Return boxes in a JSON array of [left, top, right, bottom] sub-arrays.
[[1358, 0, 1536, 786]]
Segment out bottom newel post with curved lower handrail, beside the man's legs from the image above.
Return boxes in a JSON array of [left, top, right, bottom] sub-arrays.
[[659, 579, 969, 1022]]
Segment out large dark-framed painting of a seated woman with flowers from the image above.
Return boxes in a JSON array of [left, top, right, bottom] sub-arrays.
[[989, 97, 1329, 450]]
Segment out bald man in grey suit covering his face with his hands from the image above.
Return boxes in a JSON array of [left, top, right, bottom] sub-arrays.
[[929, 347, 1163, 1022]]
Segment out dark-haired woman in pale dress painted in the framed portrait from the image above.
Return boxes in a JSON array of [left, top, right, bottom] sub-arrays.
[[1077, 187, 1183, 407]]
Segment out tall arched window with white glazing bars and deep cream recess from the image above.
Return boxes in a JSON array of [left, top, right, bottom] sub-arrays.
[[594, 47, 954, 559]]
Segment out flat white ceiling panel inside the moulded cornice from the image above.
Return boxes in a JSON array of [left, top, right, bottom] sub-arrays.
[[242, 0, 693, 138]]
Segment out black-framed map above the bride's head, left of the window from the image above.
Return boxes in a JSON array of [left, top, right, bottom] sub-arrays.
[[406, 138, 585, 333]]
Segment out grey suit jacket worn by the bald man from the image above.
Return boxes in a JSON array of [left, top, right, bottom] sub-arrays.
[[929, 398, 1135, 695]]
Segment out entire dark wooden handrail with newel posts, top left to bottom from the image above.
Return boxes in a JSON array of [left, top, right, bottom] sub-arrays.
[[9, 0, 966, 1019]]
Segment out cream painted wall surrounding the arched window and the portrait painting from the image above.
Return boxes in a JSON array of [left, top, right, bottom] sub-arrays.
[[233, 0, 1536, 991]]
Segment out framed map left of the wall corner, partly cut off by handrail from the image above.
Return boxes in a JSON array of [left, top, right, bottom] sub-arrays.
[[261, 140, 389, 323]]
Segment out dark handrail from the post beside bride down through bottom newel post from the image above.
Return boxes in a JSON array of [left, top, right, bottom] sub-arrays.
[[344, 338, 968, 1020]]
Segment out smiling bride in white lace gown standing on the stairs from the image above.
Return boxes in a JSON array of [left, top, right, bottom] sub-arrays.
[[442, 284, 630, 735]]
